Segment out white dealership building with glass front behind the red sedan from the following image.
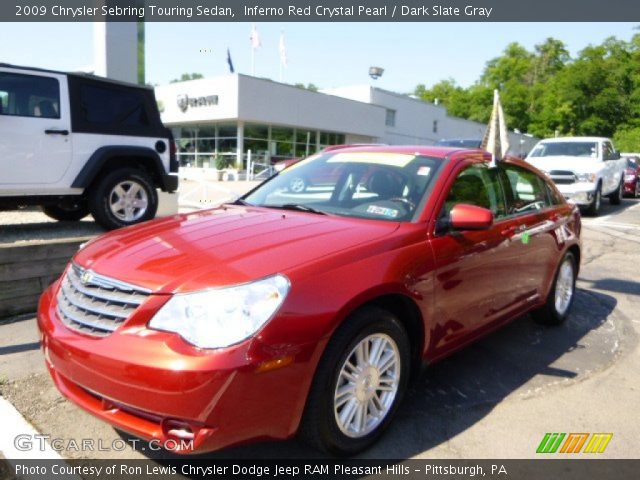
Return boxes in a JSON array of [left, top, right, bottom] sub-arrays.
[[155, 74, 536, 173]]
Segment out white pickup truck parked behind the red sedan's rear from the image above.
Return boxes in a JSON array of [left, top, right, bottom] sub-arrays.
[[526, 137, 626, 216]]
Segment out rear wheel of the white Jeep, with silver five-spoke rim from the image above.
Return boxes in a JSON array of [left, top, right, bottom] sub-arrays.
[[89, 168, 158, 230]]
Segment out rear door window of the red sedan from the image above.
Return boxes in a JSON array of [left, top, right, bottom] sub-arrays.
[[503, 165, 551, 215]]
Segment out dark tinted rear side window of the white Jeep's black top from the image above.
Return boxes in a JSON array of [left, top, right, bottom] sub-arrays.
[[80, 85, 149, 126]]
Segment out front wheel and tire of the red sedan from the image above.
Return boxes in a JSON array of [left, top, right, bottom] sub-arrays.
[[300, 307, 411, 456]]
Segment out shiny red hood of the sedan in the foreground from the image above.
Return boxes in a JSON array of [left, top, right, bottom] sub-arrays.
[[74, 206, 399, 293]]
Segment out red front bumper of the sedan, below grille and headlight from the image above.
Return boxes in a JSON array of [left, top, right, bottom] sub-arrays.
[[38, 283, 318, 453]]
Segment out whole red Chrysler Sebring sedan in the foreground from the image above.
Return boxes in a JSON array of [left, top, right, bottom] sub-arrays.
[[38, 146, 580, 455]]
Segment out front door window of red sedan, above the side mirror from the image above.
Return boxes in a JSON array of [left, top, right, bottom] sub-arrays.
[[441, 164, 506, 218]]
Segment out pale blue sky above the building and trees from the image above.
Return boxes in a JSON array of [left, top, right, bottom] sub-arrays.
[[0, 22, 638, 93]]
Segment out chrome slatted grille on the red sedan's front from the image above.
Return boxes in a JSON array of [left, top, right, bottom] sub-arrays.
[[57, 265, 150, 337]]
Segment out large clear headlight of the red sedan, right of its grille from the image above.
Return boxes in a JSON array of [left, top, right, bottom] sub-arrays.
[[149, 275, 290, 348]]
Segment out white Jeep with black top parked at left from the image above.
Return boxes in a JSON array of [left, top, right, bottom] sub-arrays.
[[0, 64, 178, 229]]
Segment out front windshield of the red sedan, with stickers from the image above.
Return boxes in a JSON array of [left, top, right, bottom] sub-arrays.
[[239, 152, 440, 222]]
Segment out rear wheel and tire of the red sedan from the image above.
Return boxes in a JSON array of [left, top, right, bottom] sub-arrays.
[[531, 252, 578, 325]]
